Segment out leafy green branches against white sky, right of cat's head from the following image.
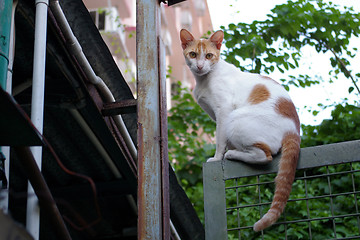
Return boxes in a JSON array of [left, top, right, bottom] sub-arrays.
[[222, 0, 360, 93]]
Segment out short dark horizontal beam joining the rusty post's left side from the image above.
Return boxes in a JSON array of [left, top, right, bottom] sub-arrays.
[[101, 99, 137, 116]]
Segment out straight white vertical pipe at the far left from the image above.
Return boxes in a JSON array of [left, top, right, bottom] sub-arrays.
[[26, 0, 49, 239]]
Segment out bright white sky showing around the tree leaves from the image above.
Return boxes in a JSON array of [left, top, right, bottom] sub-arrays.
[[207, 0, 360, 125]]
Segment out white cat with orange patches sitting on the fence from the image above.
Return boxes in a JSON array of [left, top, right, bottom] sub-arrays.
[[180, 29, 300, 231]]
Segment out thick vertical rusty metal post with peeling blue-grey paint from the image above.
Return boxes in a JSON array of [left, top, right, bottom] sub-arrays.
[[136, 0, 170, 240]]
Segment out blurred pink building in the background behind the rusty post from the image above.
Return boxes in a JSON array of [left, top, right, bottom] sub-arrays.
[[83, 0, 213, 105]]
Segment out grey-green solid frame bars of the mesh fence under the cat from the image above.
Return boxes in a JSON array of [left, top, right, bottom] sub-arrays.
[[203, 140, 360, 240]]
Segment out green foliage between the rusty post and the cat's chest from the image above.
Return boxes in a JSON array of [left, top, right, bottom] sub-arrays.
[[168, 83, 215, 221]]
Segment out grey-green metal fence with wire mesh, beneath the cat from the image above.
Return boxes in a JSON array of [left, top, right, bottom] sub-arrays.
[[203, 141, 360, 239]]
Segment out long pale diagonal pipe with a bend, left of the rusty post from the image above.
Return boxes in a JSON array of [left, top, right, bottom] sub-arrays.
[[50, 0, 137, 159]]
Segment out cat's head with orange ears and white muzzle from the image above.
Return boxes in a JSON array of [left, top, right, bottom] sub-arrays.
[[180, 29, 224, 76]]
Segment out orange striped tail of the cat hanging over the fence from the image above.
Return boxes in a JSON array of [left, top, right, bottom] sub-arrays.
[[254, 133, 300, 232]]
